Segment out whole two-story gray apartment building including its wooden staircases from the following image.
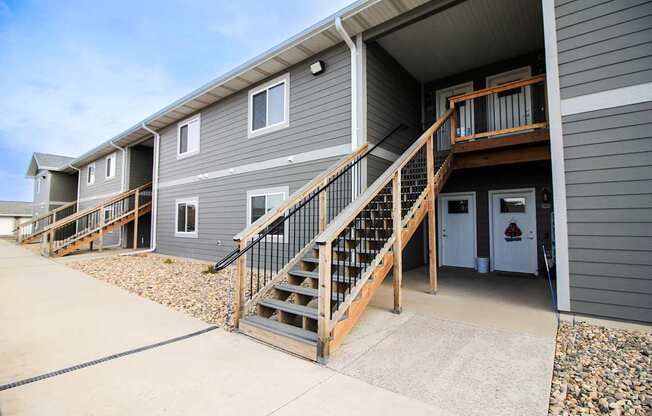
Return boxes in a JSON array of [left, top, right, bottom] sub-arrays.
[[17, 0, 652, 358]]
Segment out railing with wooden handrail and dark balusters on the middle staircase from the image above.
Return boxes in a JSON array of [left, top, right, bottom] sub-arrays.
[[43, 182, 152, 255]]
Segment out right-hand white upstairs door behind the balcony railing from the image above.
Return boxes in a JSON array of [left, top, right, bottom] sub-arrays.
[[487, 66, 532, 131]]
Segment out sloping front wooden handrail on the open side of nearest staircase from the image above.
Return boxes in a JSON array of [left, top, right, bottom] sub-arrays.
[[315, 108, 454, 245]]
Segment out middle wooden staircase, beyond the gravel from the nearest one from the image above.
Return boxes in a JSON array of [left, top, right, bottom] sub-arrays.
[[42, 183, 152, 257]]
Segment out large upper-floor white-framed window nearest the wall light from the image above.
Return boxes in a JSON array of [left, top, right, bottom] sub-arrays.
[[248, 74, 290, 137]]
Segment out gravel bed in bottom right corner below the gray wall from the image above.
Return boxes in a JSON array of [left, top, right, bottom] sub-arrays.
[[549, 322, 652, 416]]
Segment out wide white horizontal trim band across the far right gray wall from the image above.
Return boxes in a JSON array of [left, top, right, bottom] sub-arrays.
[[561, 82, 652, 116]]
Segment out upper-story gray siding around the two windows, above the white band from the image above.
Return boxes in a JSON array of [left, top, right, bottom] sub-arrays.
[[159, 44, 351, 183]]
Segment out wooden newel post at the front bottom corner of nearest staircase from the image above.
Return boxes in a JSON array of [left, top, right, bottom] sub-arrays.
[[317, 243, 332, 362]]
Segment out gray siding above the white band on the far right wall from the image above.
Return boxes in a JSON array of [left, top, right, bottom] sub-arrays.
[[556, 0, 652, 98]]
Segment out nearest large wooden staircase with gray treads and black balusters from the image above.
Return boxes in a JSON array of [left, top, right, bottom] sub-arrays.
[[222, 111, 453, 361]]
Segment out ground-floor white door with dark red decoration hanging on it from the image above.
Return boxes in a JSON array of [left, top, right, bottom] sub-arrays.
[[489, 189, 537, 274]]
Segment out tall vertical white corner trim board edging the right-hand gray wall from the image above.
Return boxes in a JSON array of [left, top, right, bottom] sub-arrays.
[[542, 0, 570, 311]]
